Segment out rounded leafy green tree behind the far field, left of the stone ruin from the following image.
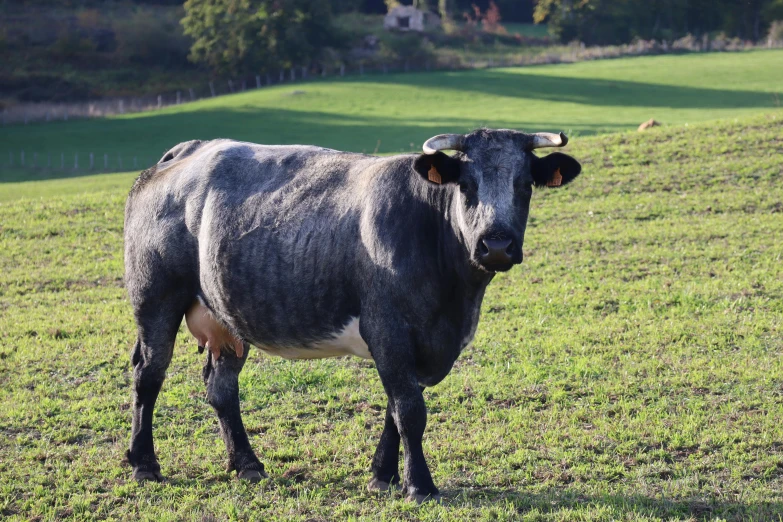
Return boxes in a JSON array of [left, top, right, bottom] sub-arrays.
[[182, 0, 334, 74]]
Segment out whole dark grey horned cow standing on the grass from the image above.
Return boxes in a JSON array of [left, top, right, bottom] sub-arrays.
[[125, 129, 581, 502]]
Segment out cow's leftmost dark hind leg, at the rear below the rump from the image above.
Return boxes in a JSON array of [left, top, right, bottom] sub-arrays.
[[127, 294, 186, 481]]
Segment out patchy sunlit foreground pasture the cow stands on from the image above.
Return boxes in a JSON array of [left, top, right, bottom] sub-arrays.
[[0, 111, 783, 522]]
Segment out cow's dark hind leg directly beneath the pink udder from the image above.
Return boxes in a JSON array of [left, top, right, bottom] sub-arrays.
[[204, 343, 266, 482]]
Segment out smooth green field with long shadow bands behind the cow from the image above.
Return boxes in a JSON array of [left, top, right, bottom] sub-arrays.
[[0, 50, 783, 183]]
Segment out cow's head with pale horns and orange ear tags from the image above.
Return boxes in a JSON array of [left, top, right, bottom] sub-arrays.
[[414, 129, 582, 272]]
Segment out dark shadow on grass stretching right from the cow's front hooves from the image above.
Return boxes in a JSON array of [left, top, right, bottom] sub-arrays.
[[442, 488, 783, 520]]
